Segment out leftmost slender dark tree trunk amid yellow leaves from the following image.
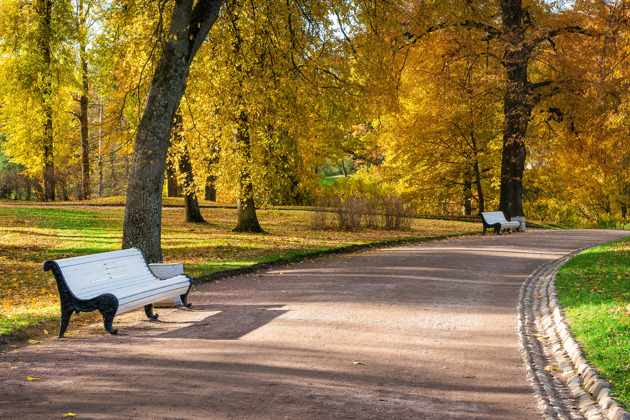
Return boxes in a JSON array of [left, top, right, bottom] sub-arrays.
[[37, 0, 55, 201]]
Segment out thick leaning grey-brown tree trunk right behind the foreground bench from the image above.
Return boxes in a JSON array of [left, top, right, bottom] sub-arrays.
[[122, 0, 223, 263]]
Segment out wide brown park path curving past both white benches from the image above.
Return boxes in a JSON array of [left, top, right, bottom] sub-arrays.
[[0, 230, 628, 420]]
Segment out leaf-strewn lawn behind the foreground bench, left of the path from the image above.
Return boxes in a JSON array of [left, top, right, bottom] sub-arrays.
[[0, 200, 479, 336]]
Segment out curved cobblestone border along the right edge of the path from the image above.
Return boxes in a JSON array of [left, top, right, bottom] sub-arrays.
[[518, 250, 630, 420]]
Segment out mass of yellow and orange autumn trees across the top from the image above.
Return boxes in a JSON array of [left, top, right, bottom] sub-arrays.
[[0, 0, 630, 261]]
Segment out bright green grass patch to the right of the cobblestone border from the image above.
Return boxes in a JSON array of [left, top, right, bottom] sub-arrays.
[[557, 239, 630, 407]]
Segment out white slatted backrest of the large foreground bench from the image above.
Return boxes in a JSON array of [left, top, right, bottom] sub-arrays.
[[55, 248, 156, 299]]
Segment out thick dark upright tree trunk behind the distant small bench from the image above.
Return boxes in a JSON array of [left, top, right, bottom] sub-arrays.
[[499, 0, 533, 219]]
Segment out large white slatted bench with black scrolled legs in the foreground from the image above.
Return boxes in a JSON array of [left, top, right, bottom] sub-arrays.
[[44, 248, 192, 338]]
